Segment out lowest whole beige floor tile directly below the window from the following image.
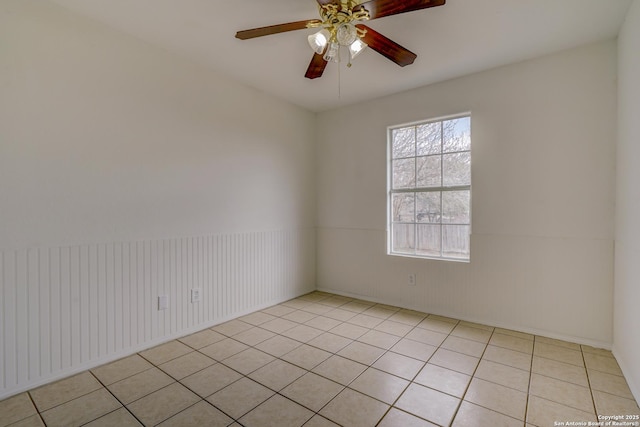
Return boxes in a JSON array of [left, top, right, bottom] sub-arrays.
[[395, 384, 460, 426]]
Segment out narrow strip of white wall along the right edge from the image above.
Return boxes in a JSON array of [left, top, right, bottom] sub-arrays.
[[613, 0, 640, 401]]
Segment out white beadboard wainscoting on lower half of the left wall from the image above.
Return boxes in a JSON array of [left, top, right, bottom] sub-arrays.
[[0, 229, 315, 399]]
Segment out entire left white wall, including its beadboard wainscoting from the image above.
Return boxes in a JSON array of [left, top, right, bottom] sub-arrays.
[[0, 0, 315, 399]]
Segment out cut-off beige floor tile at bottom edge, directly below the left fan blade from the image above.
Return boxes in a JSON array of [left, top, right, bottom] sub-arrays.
[[239, 395, 313, 427]]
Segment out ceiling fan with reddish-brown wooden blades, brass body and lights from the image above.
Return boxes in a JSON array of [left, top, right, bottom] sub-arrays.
[[236, 0, 446, 79]]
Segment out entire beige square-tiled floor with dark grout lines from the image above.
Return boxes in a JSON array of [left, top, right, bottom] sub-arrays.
[[0, 292, 640, 427]]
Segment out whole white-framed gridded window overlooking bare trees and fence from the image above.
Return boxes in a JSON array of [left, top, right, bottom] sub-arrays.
[[388, 115, 471, 261]]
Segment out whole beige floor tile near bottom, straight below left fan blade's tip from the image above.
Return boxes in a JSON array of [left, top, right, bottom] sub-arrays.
[[207, 377, 275, 419]]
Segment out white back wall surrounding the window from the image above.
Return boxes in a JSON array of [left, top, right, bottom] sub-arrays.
[[317, 41, 616, 347]]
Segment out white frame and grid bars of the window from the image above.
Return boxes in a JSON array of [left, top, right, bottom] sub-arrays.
[[387, 112, 473, 263]]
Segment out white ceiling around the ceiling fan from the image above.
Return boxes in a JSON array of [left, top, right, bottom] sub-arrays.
[[50, 0, 631, 111]]
